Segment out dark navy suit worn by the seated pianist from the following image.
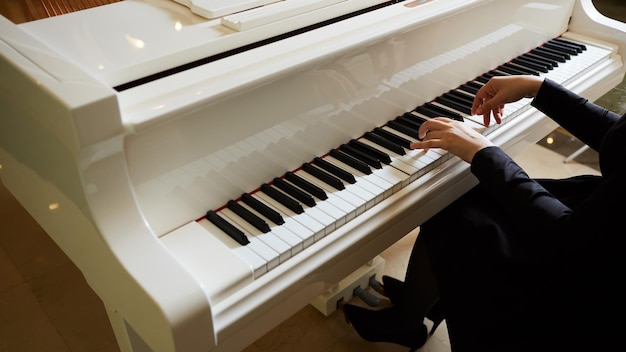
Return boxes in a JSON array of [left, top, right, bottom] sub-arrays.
[[414, 80, 626, 351]]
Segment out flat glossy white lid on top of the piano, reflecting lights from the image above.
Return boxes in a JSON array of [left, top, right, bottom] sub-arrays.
[[19, 0, 395, 90]]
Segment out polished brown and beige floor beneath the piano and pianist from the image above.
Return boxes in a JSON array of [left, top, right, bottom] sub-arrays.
[[0, 0, 626, 352]]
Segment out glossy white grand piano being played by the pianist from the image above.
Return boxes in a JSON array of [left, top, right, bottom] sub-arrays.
[[0, 0, 626, 352]]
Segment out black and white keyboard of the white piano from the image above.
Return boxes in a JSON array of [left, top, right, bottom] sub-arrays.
[[163, 38, 611, 288]]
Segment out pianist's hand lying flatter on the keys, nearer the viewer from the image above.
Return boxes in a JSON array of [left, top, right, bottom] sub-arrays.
[[411, 117, 493, 163]]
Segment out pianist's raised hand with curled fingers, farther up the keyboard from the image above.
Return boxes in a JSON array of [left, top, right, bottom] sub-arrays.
[[472, 76, 543, 126]]
